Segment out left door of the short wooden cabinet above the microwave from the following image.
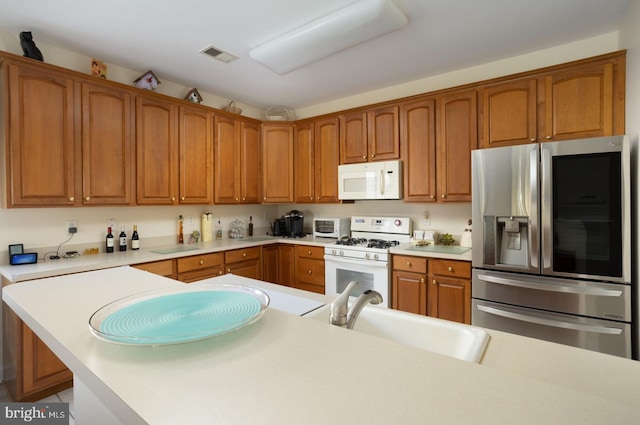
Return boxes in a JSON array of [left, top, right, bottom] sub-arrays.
[[340, 111, 368, 164]]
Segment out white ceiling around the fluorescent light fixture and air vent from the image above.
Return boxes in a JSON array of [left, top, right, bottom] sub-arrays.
[[0, 0, 629, 108]]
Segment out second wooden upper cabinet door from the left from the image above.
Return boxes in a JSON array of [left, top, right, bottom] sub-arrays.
[[81, 82, 135, 205]]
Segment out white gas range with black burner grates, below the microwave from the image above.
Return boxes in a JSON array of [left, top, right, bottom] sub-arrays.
[[324, 216, 411, 307]]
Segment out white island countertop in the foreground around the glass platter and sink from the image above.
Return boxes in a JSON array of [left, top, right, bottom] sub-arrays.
[[3, 267, 640, 425]]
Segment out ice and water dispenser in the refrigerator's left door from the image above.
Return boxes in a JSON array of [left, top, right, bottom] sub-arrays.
[[484, 216, 531, 270]]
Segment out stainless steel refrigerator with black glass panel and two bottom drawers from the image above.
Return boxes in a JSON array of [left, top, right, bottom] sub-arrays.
[[471, 136, 637, 358]]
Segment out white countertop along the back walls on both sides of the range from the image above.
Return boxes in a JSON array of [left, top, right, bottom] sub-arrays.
[[0, 236, 471, 283]]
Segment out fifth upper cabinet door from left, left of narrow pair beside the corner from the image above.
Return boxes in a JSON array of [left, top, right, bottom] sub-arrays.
[[213, 115, 240, 204]]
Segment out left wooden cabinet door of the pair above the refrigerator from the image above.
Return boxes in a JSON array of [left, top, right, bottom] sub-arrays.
[[479, 78, 538, 148]]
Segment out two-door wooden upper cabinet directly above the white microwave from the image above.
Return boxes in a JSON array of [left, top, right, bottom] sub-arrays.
[[340, 105, 400, 164]]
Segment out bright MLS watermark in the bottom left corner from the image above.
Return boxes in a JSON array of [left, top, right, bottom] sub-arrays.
[[0, 403, 69, 425]]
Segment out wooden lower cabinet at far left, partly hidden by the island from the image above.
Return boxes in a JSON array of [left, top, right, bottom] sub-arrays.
[[2, 303, 73, 402]]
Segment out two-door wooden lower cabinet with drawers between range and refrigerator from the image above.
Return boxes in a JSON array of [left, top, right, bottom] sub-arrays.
[[391, 255, 471, 324]]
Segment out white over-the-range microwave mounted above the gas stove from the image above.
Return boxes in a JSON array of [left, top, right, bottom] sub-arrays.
[[338, 160, 402, 200]]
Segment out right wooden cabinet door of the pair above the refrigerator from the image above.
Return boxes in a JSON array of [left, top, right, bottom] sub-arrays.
[[544, 62, 614, 140]]
